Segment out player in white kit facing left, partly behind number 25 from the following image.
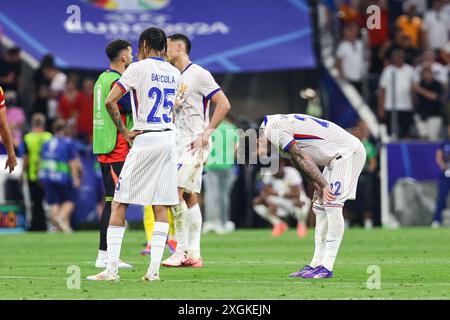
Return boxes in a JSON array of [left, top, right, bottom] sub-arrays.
[[162, 34, 231, 267]]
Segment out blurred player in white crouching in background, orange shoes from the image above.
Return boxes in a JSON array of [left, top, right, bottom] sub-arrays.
[[253, 158, 311, 238]]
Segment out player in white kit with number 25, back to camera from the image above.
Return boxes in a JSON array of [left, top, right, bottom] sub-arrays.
[[88, 28, 180, 281]]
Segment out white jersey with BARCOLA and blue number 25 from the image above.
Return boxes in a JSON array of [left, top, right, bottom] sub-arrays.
[[116, 57, 180, 130]]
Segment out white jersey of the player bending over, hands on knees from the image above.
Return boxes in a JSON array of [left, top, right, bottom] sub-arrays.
[[261, 113, 361, 166]]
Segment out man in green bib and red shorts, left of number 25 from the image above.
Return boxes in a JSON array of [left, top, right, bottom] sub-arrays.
[[93, 40, 133, 268]]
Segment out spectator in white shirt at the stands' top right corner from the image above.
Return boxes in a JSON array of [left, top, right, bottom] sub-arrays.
[[423, 0, 450, 50]]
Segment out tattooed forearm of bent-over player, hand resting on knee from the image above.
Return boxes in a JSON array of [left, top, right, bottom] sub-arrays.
[[289, 144, 336, 202]]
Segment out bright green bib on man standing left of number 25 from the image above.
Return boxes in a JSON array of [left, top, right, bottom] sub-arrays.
[[93, 70, 133, 154]]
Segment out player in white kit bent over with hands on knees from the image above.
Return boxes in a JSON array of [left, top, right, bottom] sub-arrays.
[[239, 114, 366, 278]]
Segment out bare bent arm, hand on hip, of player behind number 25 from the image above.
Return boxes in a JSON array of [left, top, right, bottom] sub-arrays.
[[189, 90, 231, 151]]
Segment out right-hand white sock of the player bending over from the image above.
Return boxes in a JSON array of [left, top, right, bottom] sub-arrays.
[[322, 207, 345, 271]]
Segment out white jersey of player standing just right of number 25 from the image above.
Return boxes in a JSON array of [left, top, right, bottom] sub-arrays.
[[175, 63, 221, 141]]
